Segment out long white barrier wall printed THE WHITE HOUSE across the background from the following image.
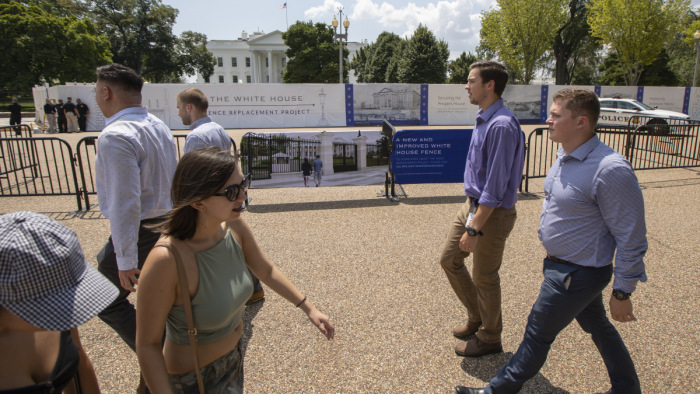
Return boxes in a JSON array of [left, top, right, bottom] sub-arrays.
[[33, 83, 700, 131]]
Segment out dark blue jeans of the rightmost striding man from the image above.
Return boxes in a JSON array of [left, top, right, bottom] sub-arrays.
[[485, 259, 641, 393]]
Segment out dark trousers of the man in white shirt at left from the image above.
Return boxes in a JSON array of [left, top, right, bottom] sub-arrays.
[[97, 218, 163, 351]]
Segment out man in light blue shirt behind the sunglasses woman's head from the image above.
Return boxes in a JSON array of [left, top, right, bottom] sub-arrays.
[[177, 88, 265, 303]]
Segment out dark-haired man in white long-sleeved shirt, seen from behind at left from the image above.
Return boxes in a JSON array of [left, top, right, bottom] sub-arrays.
[[95, 64, 177, 356]]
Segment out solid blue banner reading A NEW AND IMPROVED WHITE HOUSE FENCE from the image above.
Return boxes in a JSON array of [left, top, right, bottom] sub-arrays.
[[391, 129, 472, 184]]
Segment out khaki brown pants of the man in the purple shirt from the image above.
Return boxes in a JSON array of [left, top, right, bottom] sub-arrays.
[[440, 200, 517, 343]]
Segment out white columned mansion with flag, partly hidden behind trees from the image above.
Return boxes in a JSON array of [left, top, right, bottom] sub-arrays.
[[196, 30, 367, 83]]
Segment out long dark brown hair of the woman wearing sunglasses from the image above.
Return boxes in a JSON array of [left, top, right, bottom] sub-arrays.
[[155, 147, 238, 239]]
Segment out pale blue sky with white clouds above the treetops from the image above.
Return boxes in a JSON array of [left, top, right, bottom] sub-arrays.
[[163, 0, 700, 58]]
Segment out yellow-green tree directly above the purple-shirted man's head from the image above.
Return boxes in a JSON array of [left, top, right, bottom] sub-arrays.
[[479, 0, 568, 84]]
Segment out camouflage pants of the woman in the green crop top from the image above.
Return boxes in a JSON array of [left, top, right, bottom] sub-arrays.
[[168, 341, 243, 394]]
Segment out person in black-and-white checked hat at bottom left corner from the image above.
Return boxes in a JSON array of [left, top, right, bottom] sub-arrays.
[[0, 212, 118, 393]]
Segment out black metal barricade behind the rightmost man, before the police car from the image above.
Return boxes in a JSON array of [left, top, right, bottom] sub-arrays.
[[520, 117, 700, 192]]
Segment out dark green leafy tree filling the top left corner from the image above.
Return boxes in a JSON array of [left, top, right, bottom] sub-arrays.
[[0, 2, 111, 90]]
